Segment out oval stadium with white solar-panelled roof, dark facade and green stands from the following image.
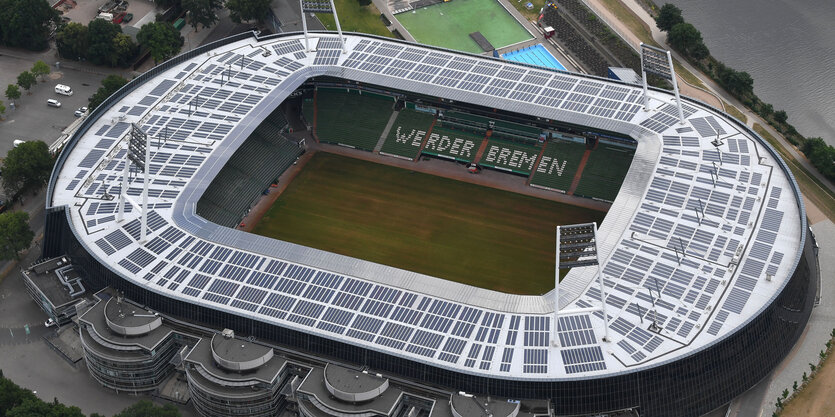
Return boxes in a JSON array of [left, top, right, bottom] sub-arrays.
[[43, 34, 819, 416]]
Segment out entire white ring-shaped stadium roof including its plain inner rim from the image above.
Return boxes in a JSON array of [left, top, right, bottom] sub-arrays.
[[48, 34, 805, 380]]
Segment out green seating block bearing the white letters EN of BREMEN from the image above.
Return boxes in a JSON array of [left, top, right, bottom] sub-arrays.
[[531, 140, 588, 192]]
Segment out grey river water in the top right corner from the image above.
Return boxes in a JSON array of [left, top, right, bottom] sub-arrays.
[[658, 0, 835, 145]]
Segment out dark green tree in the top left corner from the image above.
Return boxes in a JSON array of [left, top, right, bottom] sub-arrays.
[[0, 0, 59, 51]]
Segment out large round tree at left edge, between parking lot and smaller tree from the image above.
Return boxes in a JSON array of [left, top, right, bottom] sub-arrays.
[[2, 140, 55, 200]]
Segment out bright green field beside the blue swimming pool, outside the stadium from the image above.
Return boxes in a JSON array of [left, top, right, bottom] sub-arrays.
[[395, 0, 531, 54]]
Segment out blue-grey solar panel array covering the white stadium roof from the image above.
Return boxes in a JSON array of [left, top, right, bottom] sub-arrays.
[[56, 35, 804, 378]]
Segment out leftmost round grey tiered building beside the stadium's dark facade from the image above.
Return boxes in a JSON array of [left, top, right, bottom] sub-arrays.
[[78, 298, 178, 394]]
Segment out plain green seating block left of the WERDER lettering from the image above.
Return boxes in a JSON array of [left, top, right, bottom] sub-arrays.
[[316, 88, 394, 151]]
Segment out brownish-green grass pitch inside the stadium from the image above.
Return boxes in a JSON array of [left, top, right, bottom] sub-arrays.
[[253, 152, 605, 294]]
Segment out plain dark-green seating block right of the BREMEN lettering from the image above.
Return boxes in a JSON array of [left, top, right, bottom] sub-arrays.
[[574, 144, 633, 201]]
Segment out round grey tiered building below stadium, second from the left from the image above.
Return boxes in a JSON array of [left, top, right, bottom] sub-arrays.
[[185, 334, 289, 417]]
